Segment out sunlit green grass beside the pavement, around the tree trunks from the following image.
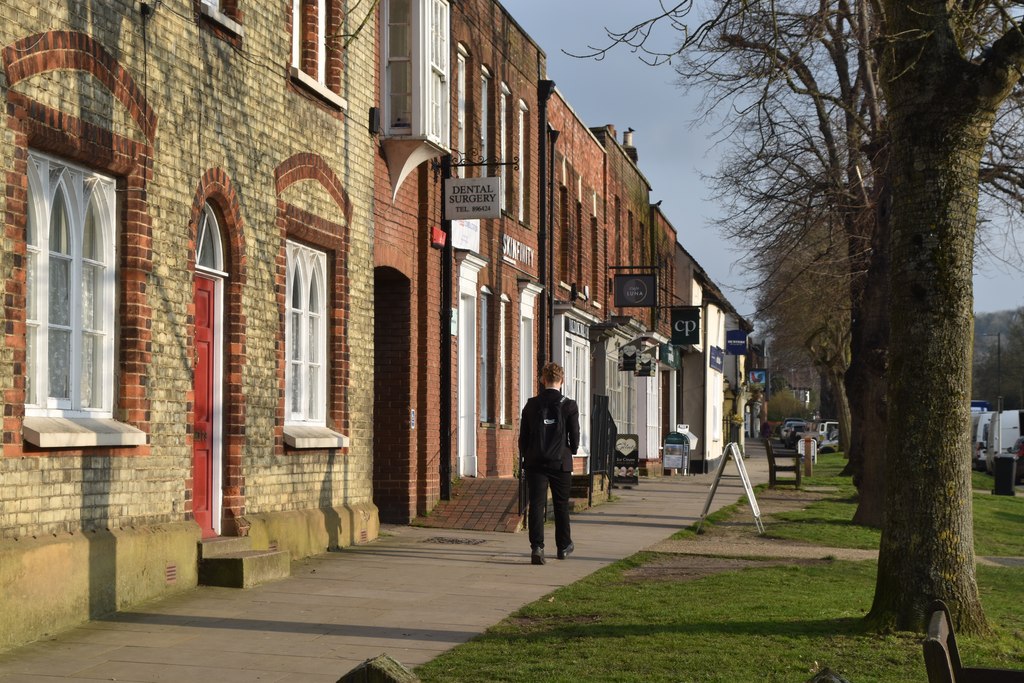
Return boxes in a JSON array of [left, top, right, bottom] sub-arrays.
[[416, 450, 1024, 683]]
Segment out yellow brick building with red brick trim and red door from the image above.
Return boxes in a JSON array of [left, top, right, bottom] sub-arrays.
[[0, 0, 378, 647]]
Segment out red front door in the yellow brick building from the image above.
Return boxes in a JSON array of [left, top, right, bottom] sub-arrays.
[[193, 275, 216, 539]]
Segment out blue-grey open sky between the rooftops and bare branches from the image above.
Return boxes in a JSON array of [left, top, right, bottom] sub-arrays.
[[501, 0, 1024, 323]]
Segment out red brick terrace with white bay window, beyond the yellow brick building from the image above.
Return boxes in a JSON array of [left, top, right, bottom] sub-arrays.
[[374, 0, 696, 522]]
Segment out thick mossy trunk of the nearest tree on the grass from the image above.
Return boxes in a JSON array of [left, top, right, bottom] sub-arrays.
[[868, 1, 993, 632]]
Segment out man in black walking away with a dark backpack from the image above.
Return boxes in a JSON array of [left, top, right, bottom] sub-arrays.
[[519, 362, 580, 564]]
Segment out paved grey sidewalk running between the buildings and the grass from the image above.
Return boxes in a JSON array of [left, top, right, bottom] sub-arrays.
[[0, 443, 768, 683]]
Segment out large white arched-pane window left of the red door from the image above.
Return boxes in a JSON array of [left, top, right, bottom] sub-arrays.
[[26, 153, 115, 417]]
